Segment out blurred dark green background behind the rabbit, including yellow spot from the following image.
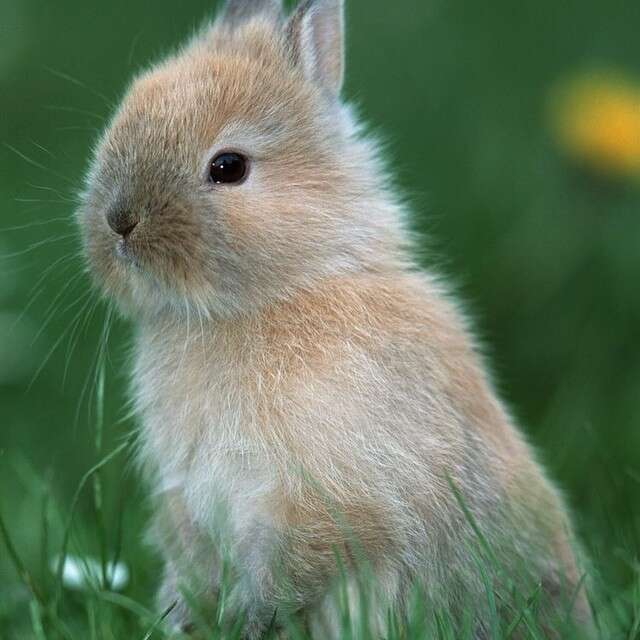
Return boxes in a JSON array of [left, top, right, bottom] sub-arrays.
[[0, 0, 640, 637]]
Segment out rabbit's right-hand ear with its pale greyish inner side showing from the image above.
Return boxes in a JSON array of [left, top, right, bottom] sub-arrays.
[[286, 0, 344, 97]]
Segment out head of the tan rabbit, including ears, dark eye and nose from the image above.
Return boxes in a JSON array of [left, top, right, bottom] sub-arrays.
[[78, 0, 402, 315]]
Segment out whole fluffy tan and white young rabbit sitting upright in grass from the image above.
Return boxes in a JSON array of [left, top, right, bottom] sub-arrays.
[[77, 0, 590, 639]]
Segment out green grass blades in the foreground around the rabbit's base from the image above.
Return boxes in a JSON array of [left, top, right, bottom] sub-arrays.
[[0, 418, 640, 640]]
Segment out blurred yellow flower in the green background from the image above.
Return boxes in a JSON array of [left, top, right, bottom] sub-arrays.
[[552, 73, 640, 177]]
